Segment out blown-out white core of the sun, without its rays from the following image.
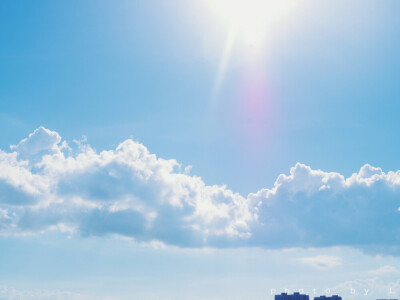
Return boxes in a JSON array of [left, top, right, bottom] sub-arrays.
[[207, 0, 296, 47]]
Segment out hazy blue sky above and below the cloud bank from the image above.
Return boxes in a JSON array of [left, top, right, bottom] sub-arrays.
[[0, 0, 400, 300]]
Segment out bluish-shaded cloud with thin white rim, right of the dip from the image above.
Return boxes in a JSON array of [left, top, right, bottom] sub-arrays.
[[248, 163, 400, 252]]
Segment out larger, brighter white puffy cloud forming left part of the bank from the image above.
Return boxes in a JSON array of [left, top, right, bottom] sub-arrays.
[[0, 128, 255, 246]]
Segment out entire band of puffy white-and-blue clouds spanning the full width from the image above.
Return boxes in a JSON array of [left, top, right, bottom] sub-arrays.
[[0, 127, 400, 253]]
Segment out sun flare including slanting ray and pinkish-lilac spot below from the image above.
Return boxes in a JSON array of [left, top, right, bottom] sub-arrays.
[[205, 0, 297, 149]]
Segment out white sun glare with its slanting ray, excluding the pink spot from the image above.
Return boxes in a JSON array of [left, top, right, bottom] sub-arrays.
[[206, 0, 297, 105]]
